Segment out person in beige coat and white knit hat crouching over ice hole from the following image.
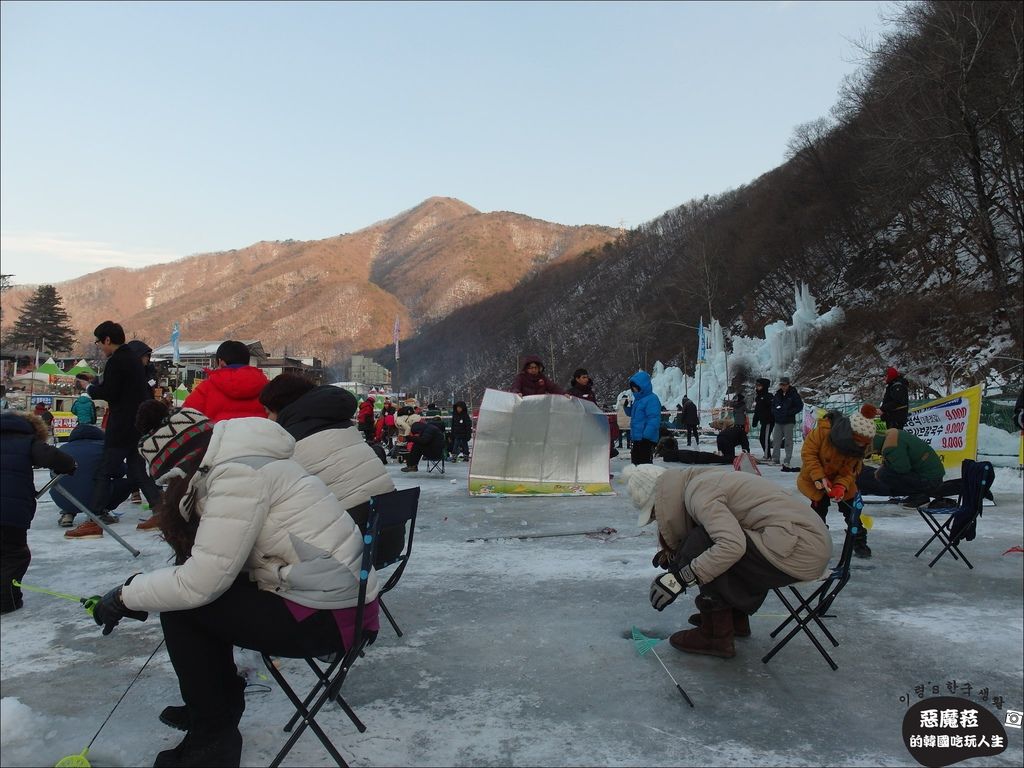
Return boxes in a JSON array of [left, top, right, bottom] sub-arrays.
[[628, 464, 831, 658]]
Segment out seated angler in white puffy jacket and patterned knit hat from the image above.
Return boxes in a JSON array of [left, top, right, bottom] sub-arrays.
[[87, 400, 379, 766]]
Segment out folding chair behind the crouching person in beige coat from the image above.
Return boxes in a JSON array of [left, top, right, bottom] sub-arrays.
[[761, 494, 864, 672]]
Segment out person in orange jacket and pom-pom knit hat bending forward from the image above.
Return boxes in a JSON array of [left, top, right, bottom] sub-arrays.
[[797, 404, 879, 557]]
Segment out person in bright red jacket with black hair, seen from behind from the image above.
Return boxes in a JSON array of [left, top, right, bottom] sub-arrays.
[[182, 341, 266, 423]]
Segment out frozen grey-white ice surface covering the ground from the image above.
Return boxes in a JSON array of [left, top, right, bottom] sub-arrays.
[[0, 454, 1024, 766]]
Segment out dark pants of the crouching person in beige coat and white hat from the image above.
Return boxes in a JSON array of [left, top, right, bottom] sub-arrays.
[[676, 525, 800, 615]]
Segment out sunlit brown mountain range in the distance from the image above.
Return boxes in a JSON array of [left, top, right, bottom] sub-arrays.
[[4, 198, 618, 361]]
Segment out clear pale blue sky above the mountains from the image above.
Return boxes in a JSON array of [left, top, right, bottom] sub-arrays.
[[0, 1, 893, 283]]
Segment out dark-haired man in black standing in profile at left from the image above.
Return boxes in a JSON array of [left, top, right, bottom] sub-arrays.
[[75, 321, 160, 523]]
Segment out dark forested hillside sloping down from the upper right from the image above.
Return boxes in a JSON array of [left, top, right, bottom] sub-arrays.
[[376, 2, 1024, 405]]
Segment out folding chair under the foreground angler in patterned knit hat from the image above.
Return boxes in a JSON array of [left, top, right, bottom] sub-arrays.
[[262, 487, 420, 768]]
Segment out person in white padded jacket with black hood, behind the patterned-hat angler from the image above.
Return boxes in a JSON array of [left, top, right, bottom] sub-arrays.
[[259, 374, 394, 530]]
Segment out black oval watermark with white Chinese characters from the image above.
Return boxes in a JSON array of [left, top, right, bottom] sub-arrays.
[[903, 696, 1007, 768]]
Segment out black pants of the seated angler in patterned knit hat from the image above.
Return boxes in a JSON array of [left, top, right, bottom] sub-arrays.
[[160, 573, 343, 730]]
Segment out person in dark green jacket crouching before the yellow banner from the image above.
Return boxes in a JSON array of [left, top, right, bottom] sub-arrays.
[[857, 429, 945, 507]]
